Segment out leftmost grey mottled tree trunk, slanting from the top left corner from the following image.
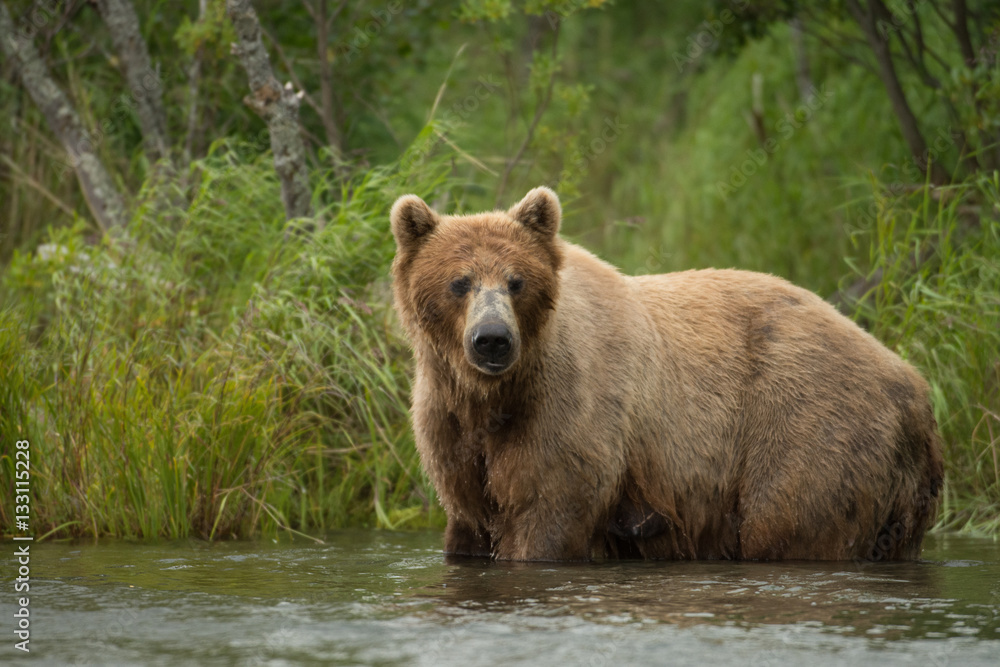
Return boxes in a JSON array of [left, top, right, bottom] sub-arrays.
[[0, 3, 125, 230]]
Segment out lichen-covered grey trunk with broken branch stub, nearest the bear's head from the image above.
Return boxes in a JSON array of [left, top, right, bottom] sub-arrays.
[[226, 0, 312, 220]]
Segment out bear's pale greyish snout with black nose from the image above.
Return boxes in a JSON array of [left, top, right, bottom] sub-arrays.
[[465, 290, 520, 375]]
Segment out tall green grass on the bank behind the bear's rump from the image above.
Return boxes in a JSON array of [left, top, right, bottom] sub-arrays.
[[854, 173, 1000, 533]]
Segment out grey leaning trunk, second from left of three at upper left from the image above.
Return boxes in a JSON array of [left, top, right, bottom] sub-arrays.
[[97, 0, 170, 162]]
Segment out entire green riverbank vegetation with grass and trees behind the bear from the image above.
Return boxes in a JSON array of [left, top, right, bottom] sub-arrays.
[[0, 0, 1000, 539]]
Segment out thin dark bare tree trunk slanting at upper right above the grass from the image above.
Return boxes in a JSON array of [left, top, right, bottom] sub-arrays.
[[847, 0, 949, 185]]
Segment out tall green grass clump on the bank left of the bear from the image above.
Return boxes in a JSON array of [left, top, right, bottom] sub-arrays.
[[0, 142, 447, 538]]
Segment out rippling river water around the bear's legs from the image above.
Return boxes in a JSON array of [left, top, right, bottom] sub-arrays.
[[0, 531, 1000, 667]]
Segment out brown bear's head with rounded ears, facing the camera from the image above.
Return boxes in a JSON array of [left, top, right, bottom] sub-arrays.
[[390, 187, 562, 382]]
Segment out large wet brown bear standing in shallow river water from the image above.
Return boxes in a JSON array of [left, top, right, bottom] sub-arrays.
[[391, 188, 942, 560]]
